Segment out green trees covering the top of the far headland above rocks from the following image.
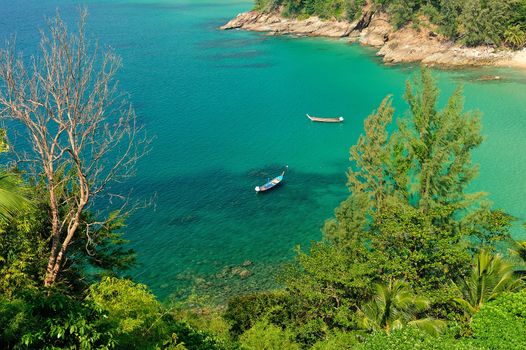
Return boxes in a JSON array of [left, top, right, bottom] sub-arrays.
[[256, 0, 526, 48]]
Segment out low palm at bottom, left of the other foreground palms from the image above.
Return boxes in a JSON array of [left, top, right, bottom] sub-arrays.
[[358, 280, 445, 334]]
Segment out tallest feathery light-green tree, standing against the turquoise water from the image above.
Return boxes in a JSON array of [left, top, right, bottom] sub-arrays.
[[400, 68, 483, 215]]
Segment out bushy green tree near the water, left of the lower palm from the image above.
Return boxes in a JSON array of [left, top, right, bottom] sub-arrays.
[[286, 240, 376, 329]]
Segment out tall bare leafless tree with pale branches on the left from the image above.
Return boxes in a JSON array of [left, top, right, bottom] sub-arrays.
[[0, 10, 148, 286]]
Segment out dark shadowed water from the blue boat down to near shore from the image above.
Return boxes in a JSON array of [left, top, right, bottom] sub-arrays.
[[123, 164, 347, 298]]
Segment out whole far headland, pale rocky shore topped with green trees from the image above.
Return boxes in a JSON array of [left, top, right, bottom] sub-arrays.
[[222, 0, 526, 68]]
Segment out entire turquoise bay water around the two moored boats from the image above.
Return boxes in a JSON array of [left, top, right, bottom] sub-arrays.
[[0, 0, 526, 297]]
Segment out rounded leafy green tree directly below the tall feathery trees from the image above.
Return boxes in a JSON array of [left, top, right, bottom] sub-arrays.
[[368, 198, 470, 294]]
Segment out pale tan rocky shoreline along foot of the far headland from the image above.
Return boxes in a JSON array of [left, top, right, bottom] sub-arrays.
[[221, 10, 526, 68]]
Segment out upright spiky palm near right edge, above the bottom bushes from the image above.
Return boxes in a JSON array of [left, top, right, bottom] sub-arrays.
[[455, 250, 524, 316]]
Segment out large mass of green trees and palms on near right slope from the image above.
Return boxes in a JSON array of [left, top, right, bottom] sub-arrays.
[[218, 69, 526, 349]]
